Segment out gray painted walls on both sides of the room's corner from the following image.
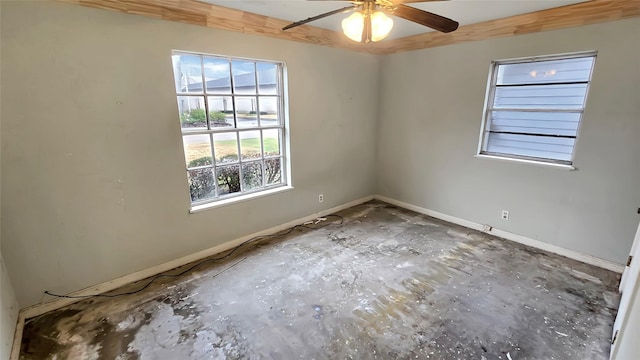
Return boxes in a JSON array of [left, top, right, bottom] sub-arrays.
[[1, 2, 640, 312]]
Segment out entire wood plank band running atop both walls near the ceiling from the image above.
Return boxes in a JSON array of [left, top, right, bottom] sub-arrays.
[[57, 0, 640, 54]]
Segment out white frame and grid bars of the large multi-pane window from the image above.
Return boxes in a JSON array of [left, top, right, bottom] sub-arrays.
[[171, 50, 292, 213]]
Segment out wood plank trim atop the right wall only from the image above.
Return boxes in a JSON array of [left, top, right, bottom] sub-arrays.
[[373, 0, 640, 54]]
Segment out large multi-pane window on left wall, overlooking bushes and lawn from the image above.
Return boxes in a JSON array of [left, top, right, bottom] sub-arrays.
[[172, 51, 287, 207]]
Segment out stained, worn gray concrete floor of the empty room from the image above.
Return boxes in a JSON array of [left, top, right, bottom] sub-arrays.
[[20, 201, 618, 360]]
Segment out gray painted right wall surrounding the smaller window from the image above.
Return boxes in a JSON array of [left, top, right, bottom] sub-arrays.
[[377, 19, 640, 263]]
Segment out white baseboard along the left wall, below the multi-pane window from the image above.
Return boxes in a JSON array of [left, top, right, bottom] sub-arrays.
[[20, 195, 373, 320]]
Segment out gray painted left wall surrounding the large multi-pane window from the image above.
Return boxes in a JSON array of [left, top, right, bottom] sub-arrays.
[[1, 2, 379, 306]]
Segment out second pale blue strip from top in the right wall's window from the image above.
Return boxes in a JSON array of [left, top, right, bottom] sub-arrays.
[[493, 84, 587, 110]]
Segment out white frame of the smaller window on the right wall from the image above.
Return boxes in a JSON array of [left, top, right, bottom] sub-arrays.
[[476, 51, 597, 170]]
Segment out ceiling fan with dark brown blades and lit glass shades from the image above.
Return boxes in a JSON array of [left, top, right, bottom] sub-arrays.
[[282, 0, 458, 43]]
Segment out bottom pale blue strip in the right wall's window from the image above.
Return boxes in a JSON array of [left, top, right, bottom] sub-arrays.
[[487, 133, 575, 161]]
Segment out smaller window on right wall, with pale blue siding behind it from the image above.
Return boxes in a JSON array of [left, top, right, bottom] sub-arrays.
[[478, 52, 596, 165]]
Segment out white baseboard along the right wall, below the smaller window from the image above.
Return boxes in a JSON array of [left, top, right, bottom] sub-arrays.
[[374, 195, 624, 273]]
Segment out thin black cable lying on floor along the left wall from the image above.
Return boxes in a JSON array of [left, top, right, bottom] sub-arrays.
[[44, 214, 344, 299]]
